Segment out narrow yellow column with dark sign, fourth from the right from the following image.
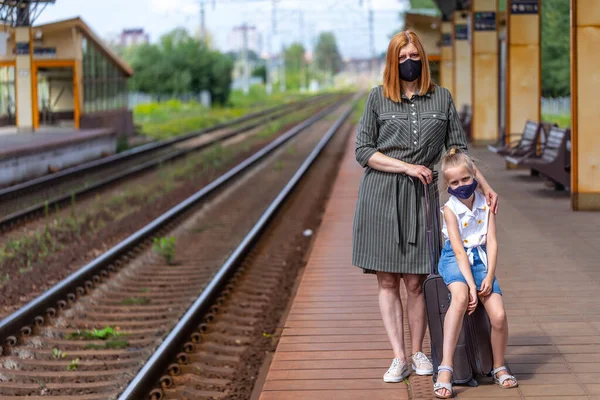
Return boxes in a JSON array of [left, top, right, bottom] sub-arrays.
[[453, 11, 472, 125]]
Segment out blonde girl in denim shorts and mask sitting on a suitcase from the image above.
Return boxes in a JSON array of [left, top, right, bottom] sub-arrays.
[[433, 148, 518, 399]]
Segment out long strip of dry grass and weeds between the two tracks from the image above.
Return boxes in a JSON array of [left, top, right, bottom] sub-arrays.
[[0, 98, 338, 288]]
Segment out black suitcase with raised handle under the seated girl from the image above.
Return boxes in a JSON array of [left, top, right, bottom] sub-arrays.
[[423, 185, 493, 386]]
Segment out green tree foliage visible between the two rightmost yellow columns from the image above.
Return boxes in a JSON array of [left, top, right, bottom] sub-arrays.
[[541, 0, 571, 97]]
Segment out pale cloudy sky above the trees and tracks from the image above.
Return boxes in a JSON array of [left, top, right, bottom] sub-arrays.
[[35, 0, 408, 58]]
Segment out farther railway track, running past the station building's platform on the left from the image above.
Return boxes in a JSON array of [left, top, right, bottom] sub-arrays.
[[0, 96, 332, 232]]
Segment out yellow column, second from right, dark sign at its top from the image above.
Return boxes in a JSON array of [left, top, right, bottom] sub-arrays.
[[505, 0, 542, 147]]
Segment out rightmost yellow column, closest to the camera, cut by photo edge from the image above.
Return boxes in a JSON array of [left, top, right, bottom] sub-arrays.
[[571, 0, 600, 210]]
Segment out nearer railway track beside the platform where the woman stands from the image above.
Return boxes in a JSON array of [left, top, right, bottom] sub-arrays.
[[0, 95, 350, 400]]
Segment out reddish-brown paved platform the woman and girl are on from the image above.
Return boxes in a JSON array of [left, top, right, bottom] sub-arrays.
[[255, 138, 600, 400]]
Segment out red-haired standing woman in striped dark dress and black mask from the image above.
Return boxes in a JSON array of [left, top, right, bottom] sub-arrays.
[[352, 30, 498, 382]]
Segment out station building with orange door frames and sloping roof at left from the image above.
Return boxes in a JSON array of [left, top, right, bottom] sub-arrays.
[[0, 18, 133, 134]]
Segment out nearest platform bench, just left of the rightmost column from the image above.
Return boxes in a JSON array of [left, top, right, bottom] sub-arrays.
[[505, 126, 571, 190]]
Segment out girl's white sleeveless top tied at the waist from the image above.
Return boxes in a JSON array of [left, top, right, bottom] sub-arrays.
[[441, 191, 490, 270]]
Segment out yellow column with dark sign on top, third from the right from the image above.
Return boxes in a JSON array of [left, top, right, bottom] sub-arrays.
[[471, 0, 498, 144]]
